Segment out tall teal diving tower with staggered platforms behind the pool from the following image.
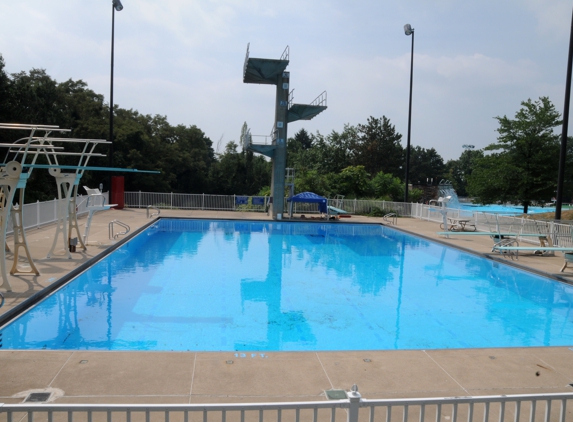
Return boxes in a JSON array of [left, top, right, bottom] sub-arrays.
[[242, 44, 326, 219]]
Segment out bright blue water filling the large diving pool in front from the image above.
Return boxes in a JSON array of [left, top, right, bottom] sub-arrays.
[[0, 219, 573, 351]]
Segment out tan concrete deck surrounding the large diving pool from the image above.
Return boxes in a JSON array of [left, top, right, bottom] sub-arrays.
[[0, 209, 573, 404]]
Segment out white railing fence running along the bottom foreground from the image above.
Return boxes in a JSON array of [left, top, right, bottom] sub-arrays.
[[0, 390, 573, 422]]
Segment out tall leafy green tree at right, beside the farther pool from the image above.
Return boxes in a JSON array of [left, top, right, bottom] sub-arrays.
[[469, 97, 561, 213]]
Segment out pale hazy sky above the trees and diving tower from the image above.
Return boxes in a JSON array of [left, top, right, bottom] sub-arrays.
[[0, 0, 573, 161]]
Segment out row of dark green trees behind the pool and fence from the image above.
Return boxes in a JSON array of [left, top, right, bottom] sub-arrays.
[[0, 55, 573, 211]]
